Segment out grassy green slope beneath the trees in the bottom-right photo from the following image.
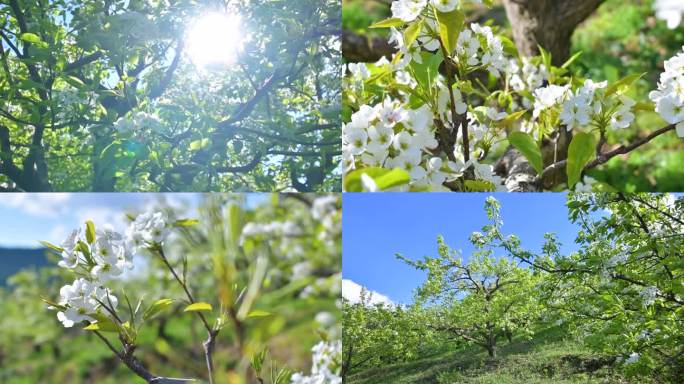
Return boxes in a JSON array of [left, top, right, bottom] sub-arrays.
[[347, 329, 627, 384]]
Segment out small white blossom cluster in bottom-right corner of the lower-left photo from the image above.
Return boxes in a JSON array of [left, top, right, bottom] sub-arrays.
[[290, 340, 342, 384]]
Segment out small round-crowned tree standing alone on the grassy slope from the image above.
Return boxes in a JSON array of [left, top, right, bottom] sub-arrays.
[[399, 219, 540, 358]]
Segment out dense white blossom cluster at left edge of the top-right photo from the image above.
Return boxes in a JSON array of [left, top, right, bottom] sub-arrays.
[[342, 93, 505, 191]]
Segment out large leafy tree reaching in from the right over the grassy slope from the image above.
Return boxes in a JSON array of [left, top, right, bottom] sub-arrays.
[[475, 193, 684, 382]]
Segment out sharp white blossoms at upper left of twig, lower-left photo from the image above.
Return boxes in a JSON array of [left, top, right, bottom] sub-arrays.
[[53, 212, 168, 328]]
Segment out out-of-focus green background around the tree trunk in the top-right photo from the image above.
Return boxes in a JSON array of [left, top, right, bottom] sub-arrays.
[[342, 0, 684, 192]]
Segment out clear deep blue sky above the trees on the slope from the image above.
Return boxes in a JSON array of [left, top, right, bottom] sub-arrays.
[[342, 193, 577, 303]]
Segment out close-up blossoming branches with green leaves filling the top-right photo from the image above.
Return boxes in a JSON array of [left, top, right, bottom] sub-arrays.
[[343, 0, 684, 191]]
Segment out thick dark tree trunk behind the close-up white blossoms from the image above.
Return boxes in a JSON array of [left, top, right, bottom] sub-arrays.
[[496, 0, 604, 192]]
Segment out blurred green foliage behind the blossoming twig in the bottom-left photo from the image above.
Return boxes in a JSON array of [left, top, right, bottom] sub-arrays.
[[0, 194, 341, 384]]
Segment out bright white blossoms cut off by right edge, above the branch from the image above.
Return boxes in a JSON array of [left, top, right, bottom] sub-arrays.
[[649, 47, 684, 137]]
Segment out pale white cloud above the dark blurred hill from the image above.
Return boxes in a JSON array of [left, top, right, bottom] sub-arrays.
[[0, 193, 71, 217]]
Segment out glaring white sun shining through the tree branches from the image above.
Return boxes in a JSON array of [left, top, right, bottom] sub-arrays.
[[185, 12, 245, 68]]
